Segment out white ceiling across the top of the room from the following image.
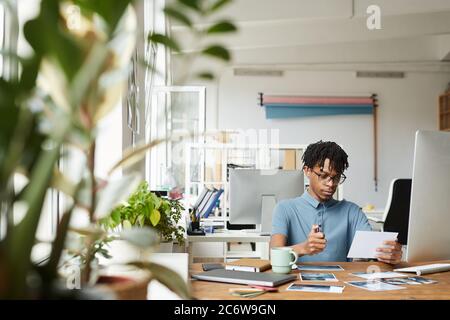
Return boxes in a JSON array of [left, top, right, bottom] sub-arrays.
[[172, 0, 450, 72]]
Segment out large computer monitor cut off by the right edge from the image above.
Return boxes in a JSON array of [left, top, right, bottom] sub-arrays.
[[406, 130, 450, 262]]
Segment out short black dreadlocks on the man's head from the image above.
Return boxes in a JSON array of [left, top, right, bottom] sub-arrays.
[[302, 140, 348, 174]]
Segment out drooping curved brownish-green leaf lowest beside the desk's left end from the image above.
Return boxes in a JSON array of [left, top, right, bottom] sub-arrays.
[[130, 262, 191, 299]]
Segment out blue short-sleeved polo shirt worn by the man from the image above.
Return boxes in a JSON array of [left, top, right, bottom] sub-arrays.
[[272, 191, 371, 262]]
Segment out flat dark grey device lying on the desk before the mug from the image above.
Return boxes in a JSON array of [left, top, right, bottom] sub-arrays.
[[192, 269, 298, 287]]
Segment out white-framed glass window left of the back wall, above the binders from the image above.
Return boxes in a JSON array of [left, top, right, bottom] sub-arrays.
[[146, 86, 206, 190]]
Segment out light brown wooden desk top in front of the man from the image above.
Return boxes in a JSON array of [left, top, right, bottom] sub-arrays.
[[190, 261, 450, 300]]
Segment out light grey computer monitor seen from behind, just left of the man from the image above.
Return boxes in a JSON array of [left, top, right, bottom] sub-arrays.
[[229, 169, 304, 234]]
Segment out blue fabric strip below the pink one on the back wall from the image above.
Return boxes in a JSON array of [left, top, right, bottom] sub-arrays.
[[265, 105, 373, 119]]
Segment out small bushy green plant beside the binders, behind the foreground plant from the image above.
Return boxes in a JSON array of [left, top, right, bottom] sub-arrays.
[[100, 181, 185, 252]]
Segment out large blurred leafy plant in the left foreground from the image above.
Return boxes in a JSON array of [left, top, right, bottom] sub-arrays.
[[0, 0, 237, 299]]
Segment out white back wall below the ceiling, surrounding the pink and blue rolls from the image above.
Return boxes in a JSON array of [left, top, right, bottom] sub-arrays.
[[214, 69, 450, 208]]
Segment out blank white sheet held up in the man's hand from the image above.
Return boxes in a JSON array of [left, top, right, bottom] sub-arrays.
[[347, 231, 398, 259]]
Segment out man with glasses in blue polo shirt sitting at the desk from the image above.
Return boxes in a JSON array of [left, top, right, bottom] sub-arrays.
[[270, 141, 402, 264]]
